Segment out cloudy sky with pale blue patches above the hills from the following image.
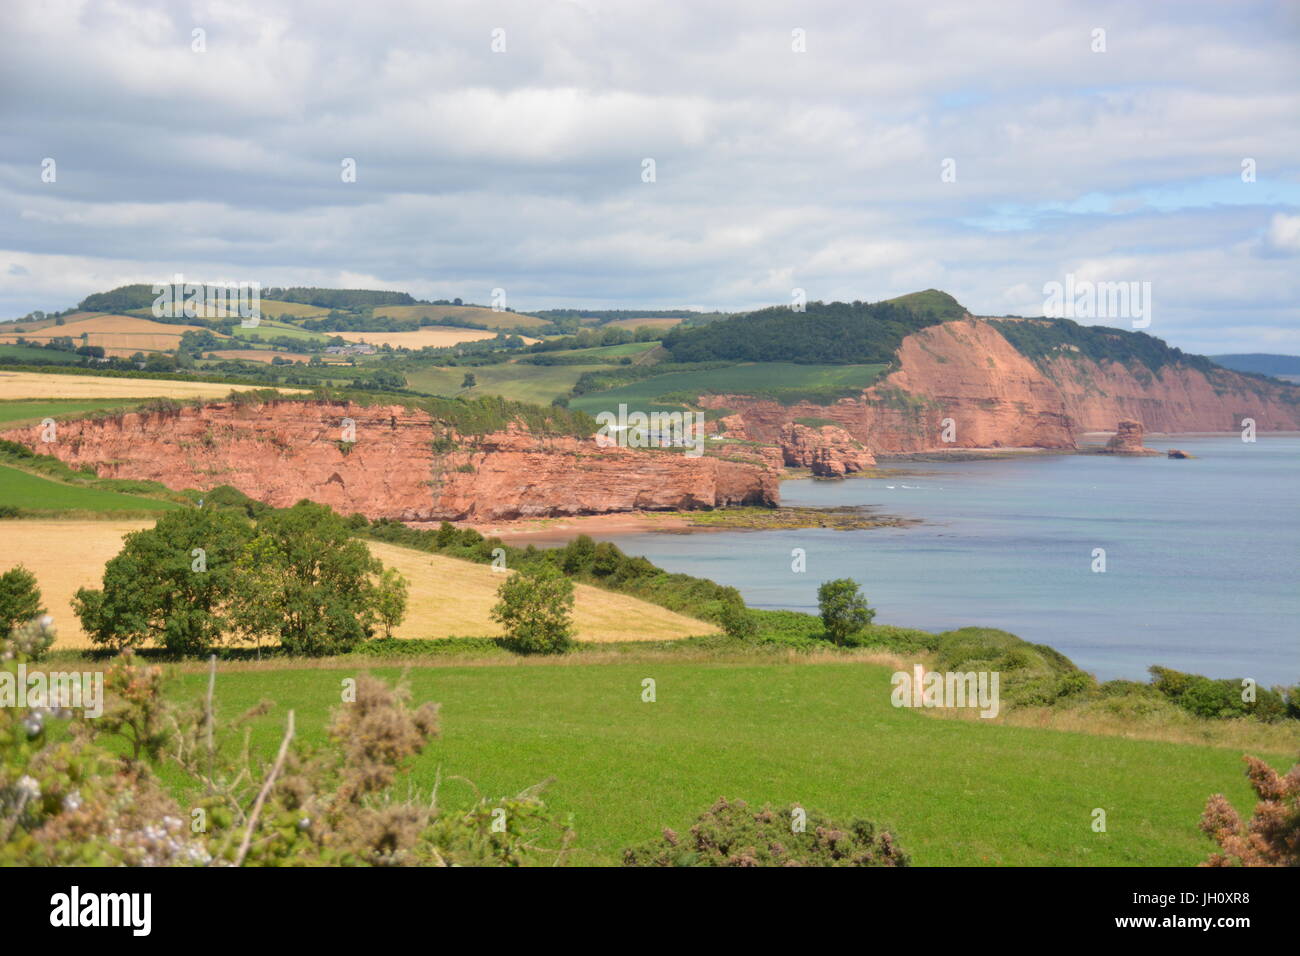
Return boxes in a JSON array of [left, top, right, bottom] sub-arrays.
[[0, 0, 1300, 354]]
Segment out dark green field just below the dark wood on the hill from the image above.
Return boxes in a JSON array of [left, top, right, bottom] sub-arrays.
[[569, 362, 885, 415]]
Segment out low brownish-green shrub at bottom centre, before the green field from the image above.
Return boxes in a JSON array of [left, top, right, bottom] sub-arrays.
[[623, 799, 909, 866]]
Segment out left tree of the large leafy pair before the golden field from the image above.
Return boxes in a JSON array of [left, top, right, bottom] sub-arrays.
[[73, 509, 252, 654]]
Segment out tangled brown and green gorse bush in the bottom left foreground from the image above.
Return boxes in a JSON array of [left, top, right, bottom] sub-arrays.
[[0, 634, 572, 866]]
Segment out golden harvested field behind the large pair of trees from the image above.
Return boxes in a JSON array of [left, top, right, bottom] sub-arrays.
[[0, 520, 718, 648]]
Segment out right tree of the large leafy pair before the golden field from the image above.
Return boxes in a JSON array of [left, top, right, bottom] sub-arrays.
[[233, 499, 390, 657]]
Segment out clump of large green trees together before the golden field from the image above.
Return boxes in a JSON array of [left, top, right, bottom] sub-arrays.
[[73, 501, 407, 656]]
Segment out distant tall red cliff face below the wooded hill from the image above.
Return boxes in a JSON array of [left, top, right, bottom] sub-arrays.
[[701, 319, 1300, 454]]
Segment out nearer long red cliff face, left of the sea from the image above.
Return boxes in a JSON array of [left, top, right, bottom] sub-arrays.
[[4, 402, 781, 520]]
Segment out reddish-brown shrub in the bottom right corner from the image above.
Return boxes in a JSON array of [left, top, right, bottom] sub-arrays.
[[1201, 757, 1300, 866]]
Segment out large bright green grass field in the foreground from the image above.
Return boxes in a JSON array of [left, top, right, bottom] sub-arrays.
[[154, 658, 1292, 866]]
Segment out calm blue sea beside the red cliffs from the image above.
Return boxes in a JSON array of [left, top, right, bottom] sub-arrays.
[[595, 437, 1300, 685]]
